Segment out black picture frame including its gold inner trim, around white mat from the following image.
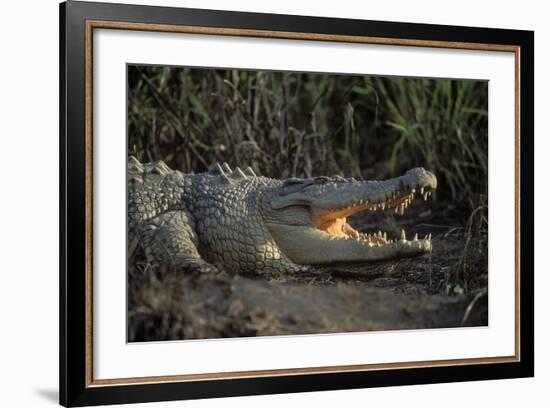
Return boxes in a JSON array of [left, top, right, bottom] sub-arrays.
[[59, 1, 534, 406]]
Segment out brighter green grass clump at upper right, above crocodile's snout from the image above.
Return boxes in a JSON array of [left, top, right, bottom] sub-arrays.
[[366, 78, 488, 204]]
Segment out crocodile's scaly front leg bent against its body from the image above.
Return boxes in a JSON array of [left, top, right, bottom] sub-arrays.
[[141, 210, 216, 272]]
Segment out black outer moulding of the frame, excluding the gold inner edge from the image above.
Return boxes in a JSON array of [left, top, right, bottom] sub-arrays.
[[59, 1, 534, 406]]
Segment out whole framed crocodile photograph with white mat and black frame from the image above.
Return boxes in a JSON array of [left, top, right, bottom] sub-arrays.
[[60, 1, 534, 406]]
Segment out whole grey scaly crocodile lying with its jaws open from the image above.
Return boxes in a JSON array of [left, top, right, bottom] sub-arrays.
[[127, 156, 437, 274]]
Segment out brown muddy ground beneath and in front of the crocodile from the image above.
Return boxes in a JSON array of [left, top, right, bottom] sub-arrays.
[[128, 204, 488, 341]]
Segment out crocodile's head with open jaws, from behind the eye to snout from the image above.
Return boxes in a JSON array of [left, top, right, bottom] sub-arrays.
[[264, 168, 437, 265]]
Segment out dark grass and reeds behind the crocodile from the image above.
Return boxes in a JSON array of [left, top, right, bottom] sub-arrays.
[[127, 66, 488, 340]]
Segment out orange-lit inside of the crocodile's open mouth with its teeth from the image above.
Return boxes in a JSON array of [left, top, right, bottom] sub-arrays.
[[313, 187, 433, 249]]
